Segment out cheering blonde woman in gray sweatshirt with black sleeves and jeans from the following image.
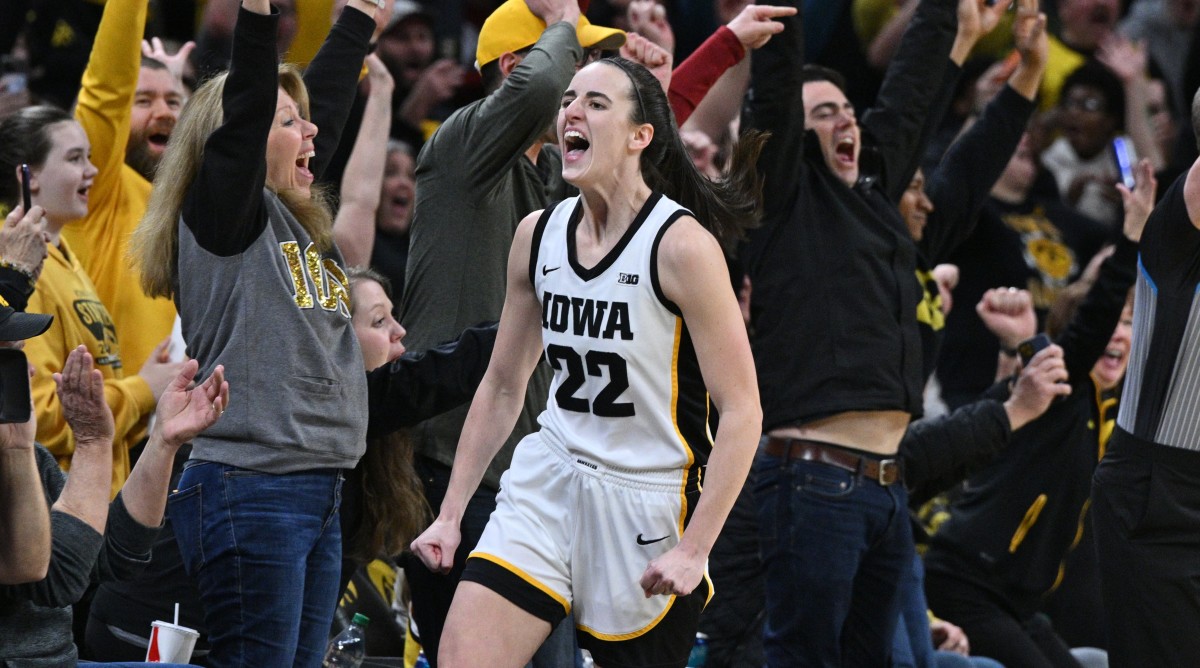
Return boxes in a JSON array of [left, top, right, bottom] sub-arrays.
[[133, 0, 376, 667]]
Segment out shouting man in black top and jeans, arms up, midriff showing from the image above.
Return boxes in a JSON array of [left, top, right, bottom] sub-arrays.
[[745, 0, 964, 666]]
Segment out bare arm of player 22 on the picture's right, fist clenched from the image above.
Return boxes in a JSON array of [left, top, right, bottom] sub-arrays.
[[641, 217, 762, 596]]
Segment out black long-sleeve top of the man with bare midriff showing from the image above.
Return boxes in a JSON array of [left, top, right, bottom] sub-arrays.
[[745, 0, 955, 431]]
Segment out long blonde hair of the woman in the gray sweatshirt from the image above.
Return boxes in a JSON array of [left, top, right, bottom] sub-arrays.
[[130, 64, 334, 297]]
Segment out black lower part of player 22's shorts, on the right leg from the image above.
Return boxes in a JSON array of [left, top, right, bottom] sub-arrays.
[[576, 578, 709, 668]]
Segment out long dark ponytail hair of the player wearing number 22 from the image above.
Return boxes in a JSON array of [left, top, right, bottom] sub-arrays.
[[598, 56, 768, 251]]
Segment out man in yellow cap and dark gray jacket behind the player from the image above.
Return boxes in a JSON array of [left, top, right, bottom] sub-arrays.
[[402, 0, 625, 666]]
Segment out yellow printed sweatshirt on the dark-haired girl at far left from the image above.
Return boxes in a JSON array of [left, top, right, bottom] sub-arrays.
[[25, 241, 155, 497]]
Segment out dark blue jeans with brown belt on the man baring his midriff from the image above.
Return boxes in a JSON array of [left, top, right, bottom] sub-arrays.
[[755, 455, 914, 668]]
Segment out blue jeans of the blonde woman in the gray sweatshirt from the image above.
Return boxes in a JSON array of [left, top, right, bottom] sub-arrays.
[[167, 461, 342, 668]]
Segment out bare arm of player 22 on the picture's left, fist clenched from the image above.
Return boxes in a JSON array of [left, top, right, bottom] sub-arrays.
[[413, 211, 542, 573]]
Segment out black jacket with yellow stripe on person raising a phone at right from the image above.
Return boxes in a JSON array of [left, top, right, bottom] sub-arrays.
[[925, 240, 1138, 615]]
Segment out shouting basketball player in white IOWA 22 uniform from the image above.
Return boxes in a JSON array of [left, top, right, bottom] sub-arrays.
[[413, 53, 762, 668]]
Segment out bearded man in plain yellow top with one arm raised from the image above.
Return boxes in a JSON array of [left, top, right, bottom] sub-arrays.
[[62, 0, 190, 369]]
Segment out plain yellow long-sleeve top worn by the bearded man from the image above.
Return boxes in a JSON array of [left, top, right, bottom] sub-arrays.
[[62, 0, 175, 374]]
